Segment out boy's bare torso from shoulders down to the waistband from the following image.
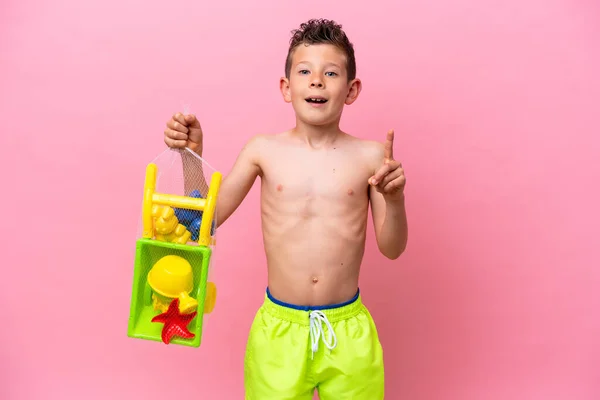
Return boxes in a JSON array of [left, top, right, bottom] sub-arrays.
[[253, 134, 378, 305]]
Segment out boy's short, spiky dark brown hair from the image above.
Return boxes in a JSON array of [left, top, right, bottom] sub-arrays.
[[285, 18, 356, 80]]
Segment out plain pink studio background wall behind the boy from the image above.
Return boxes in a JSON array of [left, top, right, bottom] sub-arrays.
[[0, 0, 600, 400]]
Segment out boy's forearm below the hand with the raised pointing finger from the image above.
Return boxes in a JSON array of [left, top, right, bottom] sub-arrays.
[[378, 196, 408, 260]]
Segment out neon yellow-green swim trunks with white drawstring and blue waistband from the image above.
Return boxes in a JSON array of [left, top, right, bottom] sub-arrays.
[[244, 289, 384, 400]]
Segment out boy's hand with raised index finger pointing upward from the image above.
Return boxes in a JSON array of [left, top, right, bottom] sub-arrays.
[[369, 130, 406, 201]]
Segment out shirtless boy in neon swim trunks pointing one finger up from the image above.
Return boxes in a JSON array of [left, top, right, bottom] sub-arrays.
[[164, 20, 407, 400]]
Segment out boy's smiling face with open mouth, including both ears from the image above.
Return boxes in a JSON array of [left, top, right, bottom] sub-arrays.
[[281, 44, 361, 125]]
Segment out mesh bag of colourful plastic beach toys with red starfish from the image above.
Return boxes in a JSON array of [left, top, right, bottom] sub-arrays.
[[127, 148, 222, 347]]
